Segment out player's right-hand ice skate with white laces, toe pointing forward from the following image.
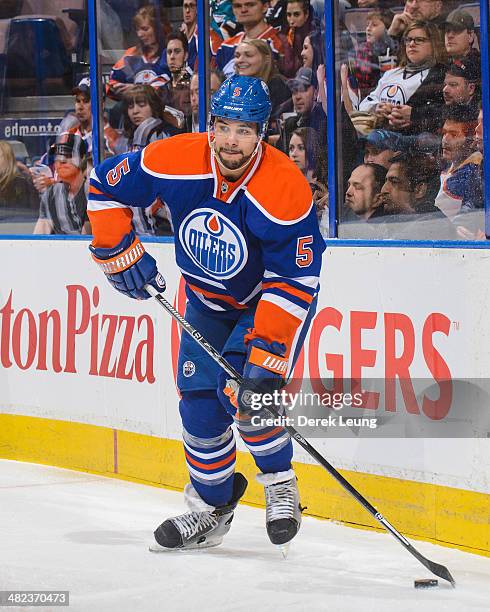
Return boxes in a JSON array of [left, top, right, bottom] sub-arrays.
[[257, 469, 301, 557]]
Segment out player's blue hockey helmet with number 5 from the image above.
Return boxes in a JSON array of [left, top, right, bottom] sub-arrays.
[[210, 74, 272, 138]]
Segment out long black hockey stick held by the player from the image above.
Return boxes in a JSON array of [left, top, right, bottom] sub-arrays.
[[145, 285, 456, 587]]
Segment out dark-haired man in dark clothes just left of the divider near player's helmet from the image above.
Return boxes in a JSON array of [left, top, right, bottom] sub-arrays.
[[159, 32, 192, 115]]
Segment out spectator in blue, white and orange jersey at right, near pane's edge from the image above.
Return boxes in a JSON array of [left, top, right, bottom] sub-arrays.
[[435, 104, 483, 220]]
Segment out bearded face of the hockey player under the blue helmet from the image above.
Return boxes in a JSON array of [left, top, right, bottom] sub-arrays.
[[214, 118, 258, 170]]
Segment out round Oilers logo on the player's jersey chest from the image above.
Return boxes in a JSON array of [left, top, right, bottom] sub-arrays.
[[179, 208, 248, 279]]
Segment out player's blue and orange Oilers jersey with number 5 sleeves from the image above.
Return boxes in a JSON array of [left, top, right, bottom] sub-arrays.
[[88, 134, 325, 354]]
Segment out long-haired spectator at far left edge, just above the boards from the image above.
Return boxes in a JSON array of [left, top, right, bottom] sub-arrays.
[[0, 140, 39, 220]]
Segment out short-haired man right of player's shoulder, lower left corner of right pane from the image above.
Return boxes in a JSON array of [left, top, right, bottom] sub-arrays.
[[342, 164, 386, 222]]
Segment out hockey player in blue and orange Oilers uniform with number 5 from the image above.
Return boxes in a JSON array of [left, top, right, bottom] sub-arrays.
[[89, 75, 325, 551]]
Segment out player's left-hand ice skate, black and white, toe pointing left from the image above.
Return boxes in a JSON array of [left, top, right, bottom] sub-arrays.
[[149, 473, 248, 552]]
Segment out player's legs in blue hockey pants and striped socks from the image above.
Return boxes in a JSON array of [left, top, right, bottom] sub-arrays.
[[177, 300, 316, 506]]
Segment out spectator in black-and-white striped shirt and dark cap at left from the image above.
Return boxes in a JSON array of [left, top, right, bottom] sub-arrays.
[[34, 132, 90, 234]]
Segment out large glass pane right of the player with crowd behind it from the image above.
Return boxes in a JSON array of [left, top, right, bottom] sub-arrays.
[[336, 0, 484, 240]]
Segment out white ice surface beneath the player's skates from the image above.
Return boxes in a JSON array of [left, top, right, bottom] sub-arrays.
[[0, 460, 490, 612]]
